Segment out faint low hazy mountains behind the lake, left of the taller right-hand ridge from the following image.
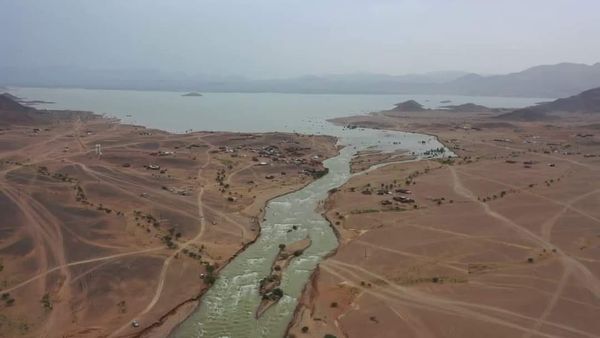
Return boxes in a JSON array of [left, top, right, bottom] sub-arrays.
[[0, 67, 468, 94]]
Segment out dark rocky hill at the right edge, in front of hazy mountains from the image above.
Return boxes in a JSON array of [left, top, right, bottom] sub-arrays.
[[498, 87, 600, 121]]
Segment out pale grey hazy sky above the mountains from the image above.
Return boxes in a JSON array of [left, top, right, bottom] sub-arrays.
[[0, 0, 600, 78]]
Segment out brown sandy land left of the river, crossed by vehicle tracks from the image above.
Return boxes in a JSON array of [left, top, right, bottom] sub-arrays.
[[0, 104, 337, 337]]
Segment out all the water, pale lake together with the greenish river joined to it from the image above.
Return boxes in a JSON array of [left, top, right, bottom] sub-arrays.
[[5, 88, 543, 338]]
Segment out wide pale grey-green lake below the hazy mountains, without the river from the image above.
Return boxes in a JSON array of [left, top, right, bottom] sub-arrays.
[[9, 88, 548, 133]]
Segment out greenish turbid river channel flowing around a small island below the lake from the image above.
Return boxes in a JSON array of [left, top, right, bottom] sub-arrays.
[[172, 129, 450, 338]]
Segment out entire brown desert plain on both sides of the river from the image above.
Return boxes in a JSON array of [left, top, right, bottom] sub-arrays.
[[0, 92, 600, 338]]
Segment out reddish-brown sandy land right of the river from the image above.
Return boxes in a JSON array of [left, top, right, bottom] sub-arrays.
[[289, 111, 600, 338]]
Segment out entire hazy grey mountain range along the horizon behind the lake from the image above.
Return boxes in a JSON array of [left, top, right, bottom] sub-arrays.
[[0, 63, 600, 98]]
